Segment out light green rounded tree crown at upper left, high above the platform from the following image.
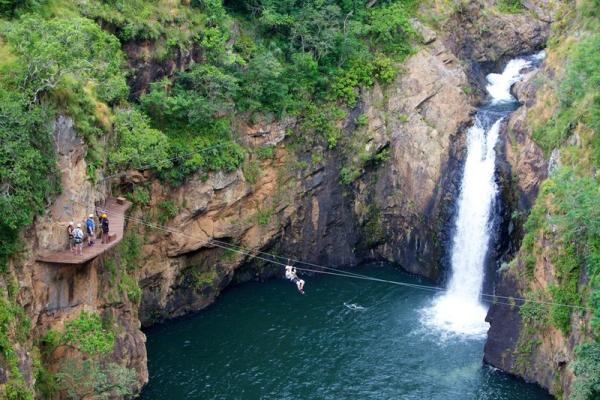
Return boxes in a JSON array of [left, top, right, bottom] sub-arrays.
[[2, 15, 128, 103]]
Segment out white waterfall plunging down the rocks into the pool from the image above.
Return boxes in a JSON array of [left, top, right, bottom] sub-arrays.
[[422, 52, 544, 337]]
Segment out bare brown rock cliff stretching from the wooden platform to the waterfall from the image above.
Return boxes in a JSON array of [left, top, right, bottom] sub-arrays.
[[3, 2, 547, 396]]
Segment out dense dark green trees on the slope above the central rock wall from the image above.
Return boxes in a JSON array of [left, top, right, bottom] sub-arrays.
[[127, 0, 416, 183]]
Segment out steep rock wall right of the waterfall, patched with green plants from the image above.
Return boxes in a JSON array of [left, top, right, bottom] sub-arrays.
[[484, 3, 595, 398]]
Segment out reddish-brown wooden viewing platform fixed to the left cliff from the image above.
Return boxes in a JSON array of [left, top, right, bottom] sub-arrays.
[[36, 198, 131, 264]]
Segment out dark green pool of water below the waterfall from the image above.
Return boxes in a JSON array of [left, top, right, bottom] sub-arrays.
[[142, 266, 550, 400]]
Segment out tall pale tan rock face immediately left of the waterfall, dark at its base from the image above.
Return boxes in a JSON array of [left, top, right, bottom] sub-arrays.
[[354, 40, 473, 279]]
